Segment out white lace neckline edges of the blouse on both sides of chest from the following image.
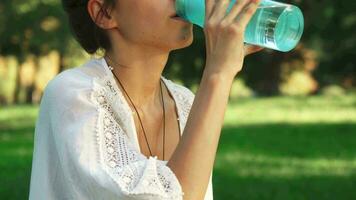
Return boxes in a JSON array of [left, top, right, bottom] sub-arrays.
[[99, 57, 183, 159]]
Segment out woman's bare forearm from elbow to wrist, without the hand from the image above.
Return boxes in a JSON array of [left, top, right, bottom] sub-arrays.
[[167, 71, 233, 200]]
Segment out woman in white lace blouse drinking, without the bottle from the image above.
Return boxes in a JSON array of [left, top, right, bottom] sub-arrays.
[[30, 0, 261, 200]]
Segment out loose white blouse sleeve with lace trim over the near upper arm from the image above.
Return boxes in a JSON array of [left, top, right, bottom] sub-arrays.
[[47, 72, 183, 200]]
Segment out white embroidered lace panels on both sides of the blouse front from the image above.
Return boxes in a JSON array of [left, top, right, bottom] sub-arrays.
[[91, 76, 193, 199]]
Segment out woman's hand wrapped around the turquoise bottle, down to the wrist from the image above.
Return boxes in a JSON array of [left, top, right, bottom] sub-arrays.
[[204, 0, 262, 78]]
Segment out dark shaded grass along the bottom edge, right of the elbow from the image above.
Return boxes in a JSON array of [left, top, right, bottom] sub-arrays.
[[213, 170, 356, 200]]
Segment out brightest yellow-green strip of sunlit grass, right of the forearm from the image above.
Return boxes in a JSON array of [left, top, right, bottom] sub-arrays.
[[225, 95, 356, 125]]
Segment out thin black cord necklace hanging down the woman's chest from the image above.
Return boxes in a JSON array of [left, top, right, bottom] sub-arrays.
[[106, 55, 170, 160]]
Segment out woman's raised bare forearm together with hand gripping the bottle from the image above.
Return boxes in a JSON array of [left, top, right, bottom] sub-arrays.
[[167, 0, 259, 200]]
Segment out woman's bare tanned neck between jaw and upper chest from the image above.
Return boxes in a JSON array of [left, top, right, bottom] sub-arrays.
[[106, 43, 168, 108]]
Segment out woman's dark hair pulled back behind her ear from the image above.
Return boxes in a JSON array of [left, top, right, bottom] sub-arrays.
[[62, 0, 116, 54]]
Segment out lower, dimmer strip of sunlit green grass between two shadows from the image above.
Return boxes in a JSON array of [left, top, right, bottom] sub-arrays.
[[215, 152, 356, 178]]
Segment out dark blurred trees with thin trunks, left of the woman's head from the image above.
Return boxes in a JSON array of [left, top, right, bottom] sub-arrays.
[[0, 0, 71, 103]]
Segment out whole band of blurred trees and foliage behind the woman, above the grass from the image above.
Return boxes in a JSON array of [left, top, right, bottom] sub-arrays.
[[0, 0, 356, 104]]
